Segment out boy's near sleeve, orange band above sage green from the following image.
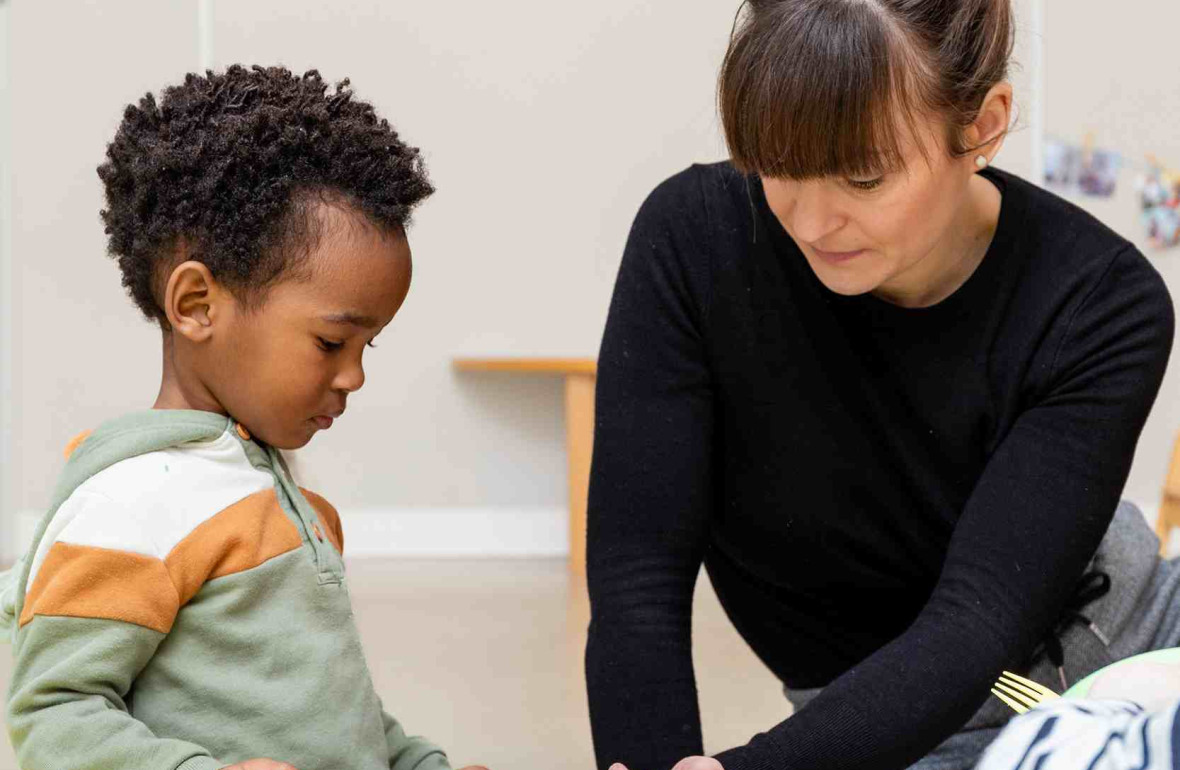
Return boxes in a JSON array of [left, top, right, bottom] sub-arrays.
[[6, 490, 225, 770]]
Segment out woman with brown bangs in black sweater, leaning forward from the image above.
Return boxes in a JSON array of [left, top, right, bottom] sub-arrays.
[[586, 0, 1180, 770]]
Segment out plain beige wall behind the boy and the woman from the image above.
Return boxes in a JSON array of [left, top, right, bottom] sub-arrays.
[[0, 0, 1180, 553]]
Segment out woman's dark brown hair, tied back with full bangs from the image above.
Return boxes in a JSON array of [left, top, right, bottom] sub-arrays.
[[719, 0, 1014, 179]]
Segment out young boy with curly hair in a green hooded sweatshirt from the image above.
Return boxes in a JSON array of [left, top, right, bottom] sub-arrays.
[[7, 66, 483, 770]]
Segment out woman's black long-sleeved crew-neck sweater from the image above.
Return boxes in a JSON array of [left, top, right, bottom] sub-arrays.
[[586, 164, 1173, 770]]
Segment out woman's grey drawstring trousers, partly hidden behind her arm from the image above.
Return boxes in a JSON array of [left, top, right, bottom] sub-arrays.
[[786, 501, 1180, 770]]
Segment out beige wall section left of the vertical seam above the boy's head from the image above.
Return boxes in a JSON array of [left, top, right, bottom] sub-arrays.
[[0, 0, 195, 551]]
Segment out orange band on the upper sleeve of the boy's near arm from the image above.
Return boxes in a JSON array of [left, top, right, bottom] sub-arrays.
[[20, 542, 181, 633]]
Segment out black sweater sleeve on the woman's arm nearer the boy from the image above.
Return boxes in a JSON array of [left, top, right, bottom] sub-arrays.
[[585, 172, 713, 770]]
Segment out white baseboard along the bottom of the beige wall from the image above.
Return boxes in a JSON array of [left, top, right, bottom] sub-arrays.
[[0, 506, 569, 562]]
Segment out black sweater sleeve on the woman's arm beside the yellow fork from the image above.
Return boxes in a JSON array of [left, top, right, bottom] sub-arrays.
[[717, 248, 1174, 770]]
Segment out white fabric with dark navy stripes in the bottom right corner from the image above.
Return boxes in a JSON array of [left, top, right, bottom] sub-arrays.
[[976, 700, 1180, 770]]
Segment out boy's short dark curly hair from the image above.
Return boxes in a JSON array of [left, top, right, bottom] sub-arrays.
[[98, 65, 434, 325]]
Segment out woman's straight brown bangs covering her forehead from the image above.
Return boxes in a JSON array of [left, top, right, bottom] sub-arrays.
[[719, 0, 922, 179]]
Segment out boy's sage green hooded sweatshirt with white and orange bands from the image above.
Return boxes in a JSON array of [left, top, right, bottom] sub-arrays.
[[0, 410, 450, 770]]
